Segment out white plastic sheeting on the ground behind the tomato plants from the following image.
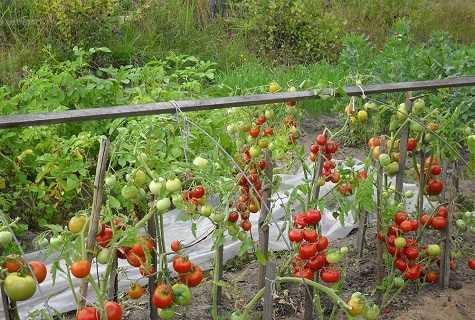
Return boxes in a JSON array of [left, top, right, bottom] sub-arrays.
[[0, 164, 428, 319]]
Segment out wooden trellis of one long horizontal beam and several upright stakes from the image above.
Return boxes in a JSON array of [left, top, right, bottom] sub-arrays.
[[0, 77, 475, 320]]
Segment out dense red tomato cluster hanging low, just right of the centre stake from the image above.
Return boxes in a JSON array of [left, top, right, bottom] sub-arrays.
[[288, 209, 343, 283]]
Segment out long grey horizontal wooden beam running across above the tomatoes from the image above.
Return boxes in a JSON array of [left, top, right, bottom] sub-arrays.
[[0, 77, 475, 129]]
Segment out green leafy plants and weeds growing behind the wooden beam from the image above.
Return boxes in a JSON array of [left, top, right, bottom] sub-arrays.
[[0, 0, 475, 229]]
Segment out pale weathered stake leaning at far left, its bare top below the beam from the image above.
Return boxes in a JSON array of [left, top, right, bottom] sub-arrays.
[[78, 137, 110, 308]]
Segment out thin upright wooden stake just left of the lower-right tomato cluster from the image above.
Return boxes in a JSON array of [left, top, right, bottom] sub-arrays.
[[375, 161, 384, 305]]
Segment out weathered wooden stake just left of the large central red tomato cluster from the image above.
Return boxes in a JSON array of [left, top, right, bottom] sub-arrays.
[[257, 150, 273, 289]]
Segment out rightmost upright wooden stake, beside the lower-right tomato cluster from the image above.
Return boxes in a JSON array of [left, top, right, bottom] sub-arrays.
[[439, 166, 457, 289]]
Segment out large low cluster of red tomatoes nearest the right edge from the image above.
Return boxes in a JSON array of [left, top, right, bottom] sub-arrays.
[[378, 207, 455, 283]]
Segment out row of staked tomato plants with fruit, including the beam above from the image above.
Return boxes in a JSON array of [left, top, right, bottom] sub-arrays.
[[0, 77, 475, 320]]
